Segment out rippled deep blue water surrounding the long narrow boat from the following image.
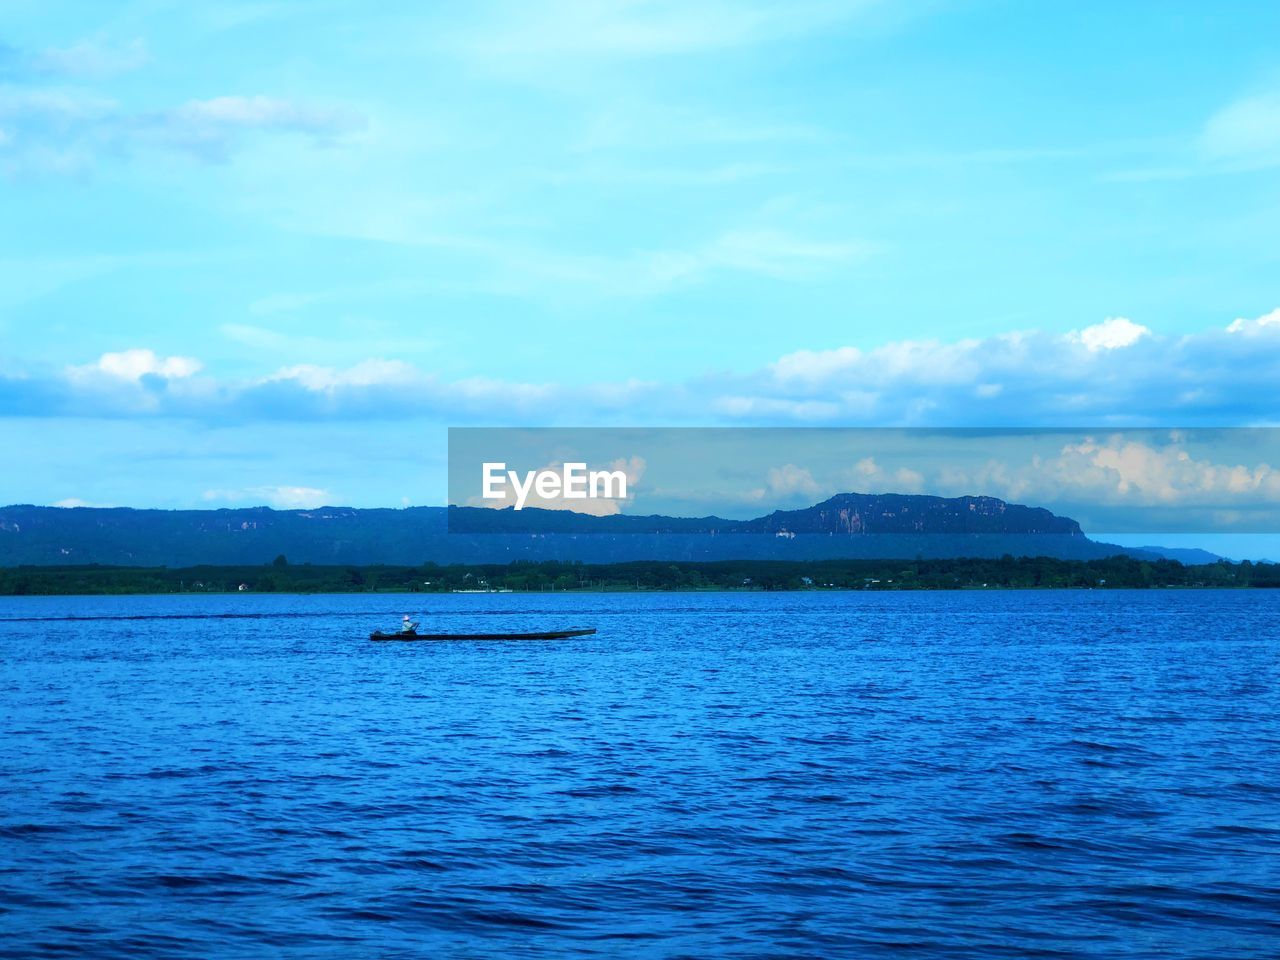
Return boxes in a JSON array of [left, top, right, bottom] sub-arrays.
[[0, 591, 1280, 960]]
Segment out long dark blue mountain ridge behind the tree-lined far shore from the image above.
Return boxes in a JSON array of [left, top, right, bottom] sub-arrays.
[[0, 493, 1216, 567]]
